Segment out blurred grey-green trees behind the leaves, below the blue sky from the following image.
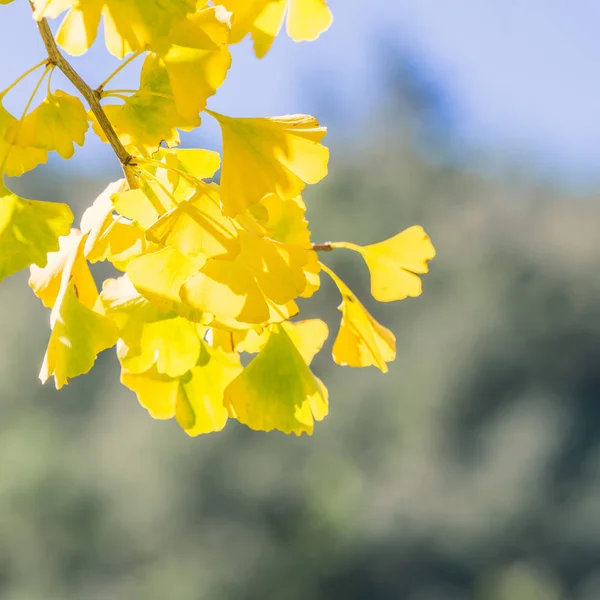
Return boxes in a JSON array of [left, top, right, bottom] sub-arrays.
[[0, 5, 600, 600]]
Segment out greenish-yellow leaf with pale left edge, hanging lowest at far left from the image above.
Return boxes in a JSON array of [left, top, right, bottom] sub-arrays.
[[40, 281, 119, 389]]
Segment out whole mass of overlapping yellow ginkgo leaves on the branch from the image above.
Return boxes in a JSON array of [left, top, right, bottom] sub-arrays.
[[0, 0, 435, 436]]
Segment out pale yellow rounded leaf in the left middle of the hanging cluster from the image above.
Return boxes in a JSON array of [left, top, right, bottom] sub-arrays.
[[127, 247, 206, 323]]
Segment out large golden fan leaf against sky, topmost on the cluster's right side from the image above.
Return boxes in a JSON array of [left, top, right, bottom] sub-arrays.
[[206, 111, 329, 217]]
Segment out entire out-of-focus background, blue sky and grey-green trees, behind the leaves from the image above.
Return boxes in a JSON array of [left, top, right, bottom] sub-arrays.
[[0, 0, 600, 600]]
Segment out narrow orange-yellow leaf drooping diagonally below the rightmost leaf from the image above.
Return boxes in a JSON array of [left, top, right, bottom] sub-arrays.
[[322, 265, 396, 373]]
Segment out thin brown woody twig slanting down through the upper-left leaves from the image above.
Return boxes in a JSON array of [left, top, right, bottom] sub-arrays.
[[38, 19, 135, 187]]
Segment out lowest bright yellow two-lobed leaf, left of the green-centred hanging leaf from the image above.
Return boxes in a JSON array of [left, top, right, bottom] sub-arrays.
[[121, 346, 242, 436]]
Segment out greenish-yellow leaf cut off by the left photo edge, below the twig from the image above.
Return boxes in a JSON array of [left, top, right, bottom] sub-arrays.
[[0, 181, 73, 281]]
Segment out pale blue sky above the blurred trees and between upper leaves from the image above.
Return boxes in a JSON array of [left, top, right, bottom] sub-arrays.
[[0, 0, 600, 183]]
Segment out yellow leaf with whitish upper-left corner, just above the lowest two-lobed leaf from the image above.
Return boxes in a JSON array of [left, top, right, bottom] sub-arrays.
[[101, 275, 206, 377]]
